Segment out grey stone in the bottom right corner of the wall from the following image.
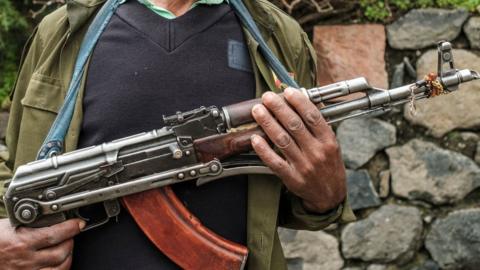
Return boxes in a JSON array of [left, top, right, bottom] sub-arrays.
[[425, 208, 480, 270]]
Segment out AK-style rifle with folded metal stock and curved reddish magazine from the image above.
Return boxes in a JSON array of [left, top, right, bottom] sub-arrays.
[[4, 42, 480, 269]]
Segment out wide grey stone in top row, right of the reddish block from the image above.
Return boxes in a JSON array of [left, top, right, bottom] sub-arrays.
[[387, 8, 468, 49]]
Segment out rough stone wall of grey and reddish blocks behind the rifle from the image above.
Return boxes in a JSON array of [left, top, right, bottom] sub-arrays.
[[280, 9, 480, 270]]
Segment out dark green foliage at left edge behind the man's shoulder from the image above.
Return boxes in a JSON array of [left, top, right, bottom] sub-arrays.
[[0, 0, 28, 102]]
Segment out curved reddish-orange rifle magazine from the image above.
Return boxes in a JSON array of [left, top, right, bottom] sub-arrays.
[[123, 187, 248, 270]]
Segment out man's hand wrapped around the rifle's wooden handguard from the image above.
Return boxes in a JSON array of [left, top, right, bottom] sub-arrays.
[[251, 88, 347, 213]]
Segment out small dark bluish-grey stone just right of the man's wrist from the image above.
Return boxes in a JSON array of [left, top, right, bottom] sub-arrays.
[[347, 170, 381, 210]]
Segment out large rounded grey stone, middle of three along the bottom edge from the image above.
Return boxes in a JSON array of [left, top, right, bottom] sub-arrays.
[[341, 205, 423, 264]]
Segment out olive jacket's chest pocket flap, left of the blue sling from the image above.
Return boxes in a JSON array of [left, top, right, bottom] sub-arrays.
[[21, 73, 64, 114]]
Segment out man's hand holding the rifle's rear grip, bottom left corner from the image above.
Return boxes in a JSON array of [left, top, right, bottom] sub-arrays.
[[0, 219, 85, 270]]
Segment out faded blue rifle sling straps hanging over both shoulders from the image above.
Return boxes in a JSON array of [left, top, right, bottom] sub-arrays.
[[37, 0, 299, 160]]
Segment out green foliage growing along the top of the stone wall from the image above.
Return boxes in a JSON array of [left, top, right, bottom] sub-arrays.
[[360, 0, 480, 22]]
